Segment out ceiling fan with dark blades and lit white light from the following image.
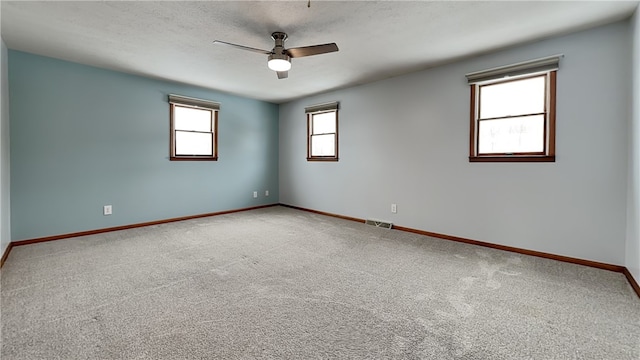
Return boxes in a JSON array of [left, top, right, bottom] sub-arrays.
[[213, 31, 338, 79]]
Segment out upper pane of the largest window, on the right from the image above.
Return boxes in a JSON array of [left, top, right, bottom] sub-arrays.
[[480, 76, 546, 119]]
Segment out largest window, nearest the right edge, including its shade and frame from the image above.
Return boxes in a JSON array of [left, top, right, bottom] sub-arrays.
[[467, 56, 560, 162]]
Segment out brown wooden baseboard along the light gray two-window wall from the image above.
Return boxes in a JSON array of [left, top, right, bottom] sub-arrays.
[[280, 204, 640, 297]]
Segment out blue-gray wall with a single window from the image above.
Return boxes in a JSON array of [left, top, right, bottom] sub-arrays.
[[9, 50, 278, 241]]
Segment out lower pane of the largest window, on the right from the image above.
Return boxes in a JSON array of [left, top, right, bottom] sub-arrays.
[[478, 115, 545, 154]]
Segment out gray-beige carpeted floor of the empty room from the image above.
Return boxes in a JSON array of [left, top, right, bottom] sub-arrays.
[[1, 207, 640, 360]]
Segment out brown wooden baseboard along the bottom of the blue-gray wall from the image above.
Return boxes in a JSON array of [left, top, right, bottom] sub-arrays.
[[2, 204, 278, 258]]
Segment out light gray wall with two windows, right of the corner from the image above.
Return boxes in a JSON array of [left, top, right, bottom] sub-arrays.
[[280, 22, 631, 265]]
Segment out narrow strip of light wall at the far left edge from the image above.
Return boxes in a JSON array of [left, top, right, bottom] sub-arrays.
[[0, 41, 11, 256]]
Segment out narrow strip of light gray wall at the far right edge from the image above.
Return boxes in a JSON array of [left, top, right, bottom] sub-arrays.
[[625, 9, 640, 283]]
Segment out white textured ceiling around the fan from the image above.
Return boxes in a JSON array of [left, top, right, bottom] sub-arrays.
[[0, 0, 638, 103]]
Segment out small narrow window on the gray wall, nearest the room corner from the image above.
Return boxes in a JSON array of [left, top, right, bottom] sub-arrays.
[[305, 102, 338, 161]]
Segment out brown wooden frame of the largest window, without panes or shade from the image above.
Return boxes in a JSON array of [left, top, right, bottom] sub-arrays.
[[469, 70, 557, 162]]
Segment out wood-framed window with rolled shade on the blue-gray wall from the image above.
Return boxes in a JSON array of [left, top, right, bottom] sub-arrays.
[[169, 95, 220, 160]]
